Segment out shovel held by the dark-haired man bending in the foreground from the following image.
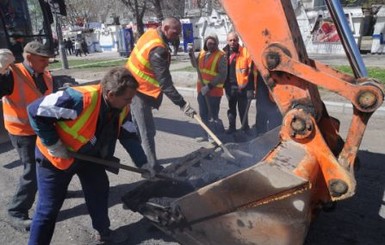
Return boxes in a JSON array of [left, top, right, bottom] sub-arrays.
[[69, 151, 182, 182]]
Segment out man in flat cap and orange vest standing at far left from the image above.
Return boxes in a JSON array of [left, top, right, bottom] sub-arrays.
[[0, 41, 54, 231]]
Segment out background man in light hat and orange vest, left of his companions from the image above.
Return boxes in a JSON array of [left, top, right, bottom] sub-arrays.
[[189, 34, 227, 143]]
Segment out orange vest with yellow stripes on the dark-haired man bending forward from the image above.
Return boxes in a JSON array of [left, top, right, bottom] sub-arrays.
[[36, 85, 129, 170]]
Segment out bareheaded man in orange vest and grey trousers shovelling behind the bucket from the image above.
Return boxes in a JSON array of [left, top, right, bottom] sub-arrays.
[[126, 17, 196, 175]]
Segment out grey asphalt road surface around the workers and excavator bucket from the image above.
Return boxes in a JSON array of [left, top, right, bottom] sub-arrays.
[[0, 87, 385, 245]]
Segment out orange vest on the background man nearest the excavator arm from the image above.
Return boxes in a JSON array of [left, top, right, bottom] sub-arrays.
[[235, 46, 251, 89]]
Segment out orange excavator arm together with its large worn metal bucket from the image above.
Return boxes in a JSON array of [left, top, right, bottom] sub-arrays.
[[122, 0, 384, 244]]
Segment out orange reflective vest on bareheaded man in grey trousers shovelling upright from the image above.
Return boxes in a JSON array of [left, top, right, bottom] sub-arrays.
[[126, 29, 167, 98]]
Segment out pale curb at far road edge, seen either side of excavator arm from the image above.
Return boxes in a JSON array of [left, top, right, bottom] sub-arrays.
[[176, 87, 385, 118]]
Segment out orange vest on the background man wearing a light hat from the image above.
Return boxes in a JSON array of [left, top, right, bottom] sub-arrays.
[[197, 50, 225, 97]]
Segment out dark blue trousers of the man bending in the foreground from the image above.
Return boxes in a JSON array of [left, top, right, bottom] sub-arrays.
[[28, 150, 110, 245]]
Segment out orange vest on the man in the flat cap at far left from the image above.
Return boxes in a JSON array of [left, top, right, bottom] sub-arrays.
[[2, 63, 53, 135]]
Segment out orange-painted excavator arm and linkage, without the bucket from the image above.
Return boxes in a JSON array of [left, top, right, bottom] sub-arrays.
[[222, 0, 384, 203]]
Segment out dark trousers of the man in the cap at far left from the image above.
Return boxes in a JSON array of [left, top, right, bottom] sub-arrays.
[[8, 134, 37, 219]]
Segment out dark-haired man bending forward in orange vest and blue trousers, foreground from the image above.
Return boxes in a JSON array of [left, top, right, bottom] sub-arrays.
[[28, 68, 145, 245]]
